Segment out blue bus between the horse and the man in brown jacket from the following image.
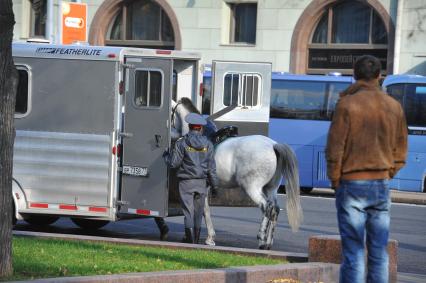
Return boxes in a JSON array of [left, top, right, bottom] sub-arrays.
[[269, 73, 353, 192]]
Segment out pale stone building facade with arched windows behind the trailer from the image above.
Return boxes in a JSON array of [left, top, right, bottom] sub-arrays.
[[13, 0, 426, 75]]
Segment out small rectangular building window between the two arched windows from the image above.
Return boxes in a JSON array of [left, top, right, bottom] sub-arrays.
[[229, 3, 257, 44]]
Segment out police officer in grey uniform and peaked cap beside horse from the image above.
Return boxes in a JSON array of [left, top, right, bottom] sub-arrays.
[[164, 113, 217, 244]]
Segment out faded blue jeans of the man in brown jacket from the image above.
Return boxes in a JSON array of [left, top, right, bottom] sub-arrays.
[[336, 180, 390, 283]]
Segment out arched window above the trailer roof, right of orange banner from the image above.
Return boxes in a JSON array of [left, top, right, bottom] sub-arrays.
[[106, 0, 175, 49]]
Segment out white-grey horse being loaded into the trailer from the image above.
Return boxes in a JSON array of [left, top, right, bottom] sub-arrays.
[[172, 98, 303, 249]]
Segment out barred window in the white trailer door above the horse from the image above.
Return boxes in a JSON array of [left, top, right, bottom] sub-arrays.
[[223, 73, 260, 108]]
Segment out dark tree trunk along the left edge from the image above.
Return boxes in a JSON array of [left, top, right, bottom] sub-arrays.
[[0, 0, 18, 278]]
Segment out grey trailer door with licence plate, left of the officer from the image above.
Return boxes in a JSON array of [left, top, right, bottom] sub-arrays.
[[120, 57, 172, 216]]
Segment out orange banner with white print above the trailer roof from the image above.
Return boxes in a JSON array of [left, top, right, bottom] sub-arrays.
[[62, 2, 87, 44]]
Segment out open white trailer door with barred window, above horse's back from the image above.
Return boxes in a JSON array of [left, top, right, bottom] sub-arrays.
[[210, 61, 272, 136]]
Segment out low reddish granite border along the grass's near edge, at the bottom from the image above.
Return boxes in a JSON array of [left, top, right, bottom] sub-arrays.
[[9, 262, 339, 283]]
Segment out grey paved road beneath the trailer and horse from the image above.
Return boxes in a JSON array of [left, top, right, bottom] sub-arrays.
[[16, 196, 426, 275]]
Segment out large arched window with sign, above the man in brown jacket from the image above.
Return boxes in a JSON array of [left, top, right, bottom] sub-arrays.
[[307, 1, 388, 74]]
